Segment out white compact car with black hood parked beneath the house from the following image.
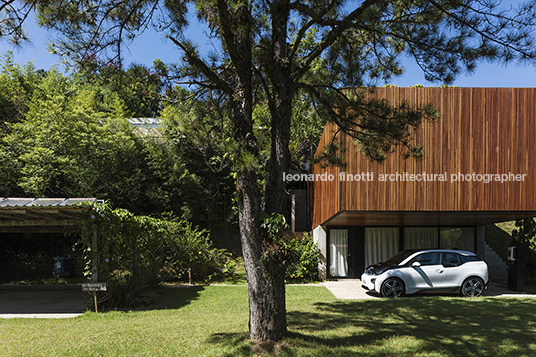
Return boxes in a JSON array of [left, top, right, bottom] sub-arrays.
[[361, 249, 489, 298]]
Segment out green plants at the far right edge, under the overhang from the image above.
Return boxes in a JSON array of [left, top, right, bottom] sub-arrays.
[[511, 218, 536, 284]]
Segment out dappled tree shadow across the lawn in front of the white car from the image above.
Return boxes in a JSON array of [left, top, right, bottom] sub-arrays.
[[207, 297, 536, 357]]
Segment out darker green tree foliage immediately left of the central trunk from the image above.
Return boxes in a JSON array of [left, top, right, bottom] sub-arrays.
[[157, 88, 237, 225]]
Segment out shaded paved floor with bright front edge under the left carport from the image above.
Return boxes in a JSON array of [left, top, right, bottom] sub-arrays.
[[0, 285, 88, 318]]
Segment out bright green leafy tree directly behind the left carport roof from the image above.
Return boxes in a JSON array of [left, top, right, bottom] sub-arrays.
[[0, 70, 147, 207]]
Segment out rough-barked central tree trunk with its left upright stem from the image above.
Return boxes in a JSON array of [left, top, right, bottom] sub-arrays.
[[232, 0, 287, 341]]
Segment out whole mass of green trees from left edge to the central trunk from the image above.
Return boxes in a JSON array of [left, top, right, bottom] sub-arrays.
[[0, 49, 236, 229]]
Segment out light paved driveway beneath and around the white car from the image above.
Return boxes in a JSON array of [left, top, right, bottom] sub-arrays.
[[322, 279, 536, 300]]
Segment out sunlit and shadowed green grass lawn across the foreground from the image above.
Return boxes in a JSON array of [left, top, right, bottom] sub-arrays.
[[0, 286, 536, 357]]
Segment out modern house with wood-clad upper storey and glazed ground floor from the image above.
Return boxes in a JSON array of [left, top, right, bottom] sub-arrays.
[[309, 87, 536, 279]]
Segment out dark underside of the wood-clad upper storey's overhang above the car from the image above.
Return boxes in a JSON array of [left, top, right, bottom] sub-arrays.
[[322, 211, 536, 227]]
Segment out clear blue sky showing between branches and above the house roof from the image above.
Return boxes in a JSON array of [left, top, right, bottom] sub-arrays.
[[0, 10, 536, 87]]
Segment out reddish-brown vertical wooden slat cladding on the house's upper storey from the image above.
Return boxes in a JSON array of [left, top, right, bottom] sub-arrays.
[[313, 87, 536, 226]]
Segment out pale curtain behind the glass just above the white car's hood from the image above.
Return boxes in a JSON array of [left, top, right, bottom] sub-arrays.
[[365, 227, 399, 267]]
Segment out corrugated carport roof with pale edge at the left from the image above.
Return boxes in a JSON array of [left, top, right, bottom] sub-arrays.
[[0, 197, 99, 233]]
